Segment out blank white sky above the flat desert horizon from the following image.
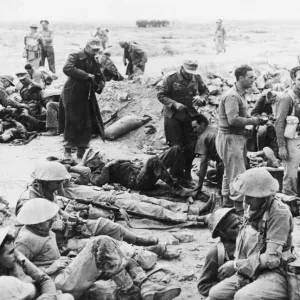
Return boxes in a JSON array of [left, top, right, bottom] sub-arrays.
[[1, 0, 300, 23]]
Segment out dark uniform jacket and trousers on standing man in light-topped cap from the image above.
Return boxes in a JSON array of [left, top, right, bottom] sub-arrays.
[[157, 71, 209, 176]]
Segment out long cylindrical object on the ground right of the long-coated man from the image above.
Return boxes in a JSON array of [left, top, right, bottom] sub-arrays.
[[105, 115, 152, 140]]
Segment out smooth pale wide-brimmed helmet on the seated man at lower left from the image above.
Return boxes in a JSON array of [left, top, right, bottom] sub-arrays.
[[17, 198, 59, 225]]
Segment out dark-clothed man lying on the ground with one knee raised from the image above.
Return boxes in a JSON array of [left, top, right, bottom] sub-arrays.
[[73, 146, 193, 196]]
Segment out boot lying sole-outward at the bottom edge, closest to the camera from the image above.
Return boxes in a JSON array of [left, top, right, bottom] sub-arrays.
[[141, 280, 181, 300]]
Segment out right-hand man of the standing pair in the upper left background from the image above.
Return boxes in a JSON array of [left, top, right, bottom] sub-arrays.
[[40, 20, 55, 74]]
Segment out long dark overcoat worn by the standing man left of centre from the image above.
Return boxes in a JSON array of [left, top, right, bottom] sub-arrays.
[[59, 50, 105, 147]]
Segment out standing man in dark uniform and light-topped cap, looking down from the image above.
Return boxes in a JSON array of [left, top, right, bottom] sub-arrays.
[[157, 60, 209, 183]]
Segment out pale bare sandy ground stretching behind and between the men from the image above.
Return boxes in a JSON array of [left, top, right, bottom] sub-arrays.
[[0, 22, 300, 300]]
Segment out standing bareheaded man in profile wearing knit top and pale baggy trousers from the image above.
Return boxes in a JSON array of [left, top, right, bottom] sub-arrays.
[[216, 65, 266, 214]]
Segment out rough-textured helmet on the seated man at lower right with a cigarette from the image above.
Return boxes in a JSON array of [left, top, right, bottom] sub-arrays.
[[232, 168, 279, 198]]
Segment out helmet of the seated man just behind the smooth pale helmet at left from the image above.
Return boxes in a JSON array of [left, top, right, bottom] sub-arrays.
[[31, 161, 71, 181]]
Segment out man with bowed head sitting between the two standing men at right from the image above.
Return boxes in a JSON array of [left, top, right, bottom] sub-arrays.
[[251, 90, 278, 156]]
